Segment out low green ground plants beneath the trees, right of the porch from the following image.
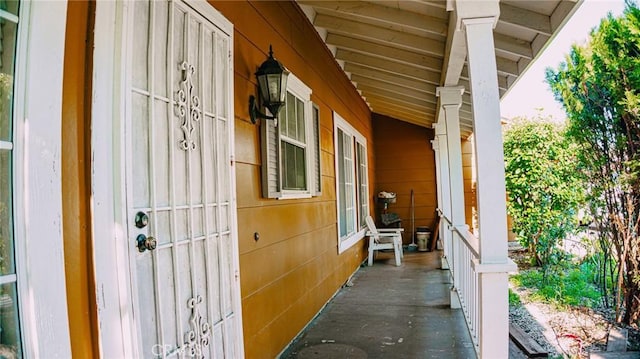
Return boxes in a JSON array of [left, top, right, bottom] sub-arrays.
[[509, 264, 601, 307]]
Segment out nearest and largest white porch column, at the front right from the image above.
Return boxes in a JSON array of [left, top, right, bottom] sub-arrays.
[[462, 8, 515, 358]]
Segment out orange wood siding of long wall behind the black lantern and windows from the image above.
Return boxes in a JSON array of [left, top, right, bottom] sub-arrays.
[[210, 1, 375, 358]]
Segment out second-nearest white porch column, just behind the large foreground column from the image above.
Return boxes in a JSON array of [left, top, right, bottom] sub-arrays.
[[436, 86, 467, 308]]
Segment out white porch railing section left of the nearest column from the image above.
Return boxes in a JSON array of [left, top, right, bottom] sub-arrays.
[[438, 210, 480, 352]]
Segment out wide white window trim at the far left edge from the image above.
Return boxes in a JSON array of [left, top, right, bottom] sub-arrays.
[[12, 1, 71, 358]]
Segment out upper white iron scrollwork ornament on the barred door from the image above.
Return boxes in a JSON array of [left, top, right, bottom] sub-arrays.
[[176, 61, 200, 151]]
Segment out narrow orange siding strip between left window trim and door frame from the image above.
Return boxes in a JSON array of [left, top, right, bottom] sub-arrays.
[[62, 1, 98, 358]]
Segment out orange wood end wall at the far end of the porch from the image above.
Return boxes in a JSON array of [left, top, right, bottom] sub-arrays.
[[373, 114, 438, 243]]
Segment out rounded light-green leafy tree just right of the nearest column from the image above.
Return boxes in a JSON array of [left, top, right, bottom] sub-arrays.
[[504, 117, 584, 274]]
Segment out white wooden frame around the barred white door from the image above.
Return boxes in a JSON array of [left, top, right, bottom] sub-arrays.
[[91, 0, 244, 358]]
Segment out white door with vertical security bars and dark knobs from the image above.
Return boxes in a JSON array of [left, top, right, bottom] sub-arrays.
[[125, 1, 242, 358]]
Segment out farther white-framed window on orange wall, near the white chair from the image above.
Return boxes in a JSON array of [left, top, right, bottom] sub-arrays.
[[334, 113, 369, 253]]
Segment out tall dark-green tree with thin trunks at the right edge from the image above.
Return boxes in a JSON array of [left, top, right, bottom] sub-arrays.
[[546, 3, 640, 324]]
